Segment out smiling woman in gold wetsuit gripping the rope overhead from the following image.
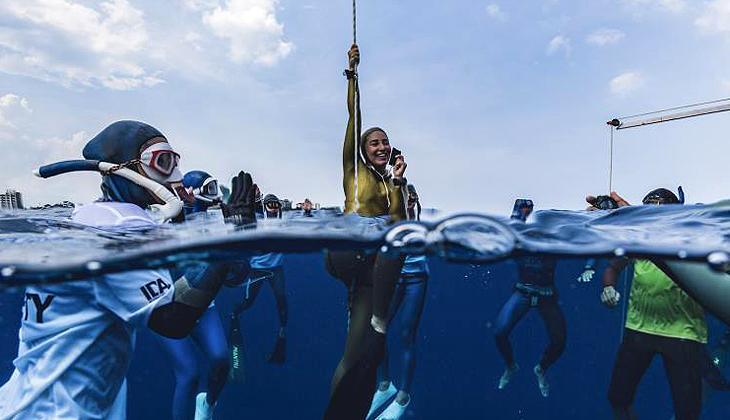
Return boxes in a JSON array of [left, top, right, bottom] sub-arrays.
[[324, 45, 407, 420]]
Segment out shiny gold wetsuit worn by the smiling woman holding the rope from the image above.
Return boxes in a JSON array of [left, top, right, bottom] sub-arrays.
[[325, 77, 407, 412]]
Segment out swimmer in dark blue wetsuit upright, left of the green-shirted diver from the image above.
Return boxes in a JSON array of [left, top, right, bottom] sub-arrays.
[[494, 199, 566, 397]]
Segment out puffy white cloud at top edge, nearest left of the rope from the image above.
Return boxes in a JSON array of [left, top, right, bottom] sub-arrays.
[[203, 0, 294, 66]]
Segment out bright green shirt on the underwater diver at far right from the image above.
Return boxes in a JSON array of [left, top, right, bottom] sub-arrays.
[[626, 260, 707, 344]]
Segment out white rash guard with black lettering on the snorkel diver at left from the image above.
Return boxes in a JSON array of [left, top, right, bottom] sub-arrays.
[[0, 203, 174, 420]]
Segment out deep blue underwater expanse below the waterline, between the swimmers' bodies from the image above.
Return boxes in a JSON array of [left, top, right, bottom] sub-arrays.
[[0, 254, 730, 420]]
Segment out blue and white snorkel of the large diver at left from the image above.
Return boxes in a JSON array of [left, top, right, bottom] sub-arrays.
[[33, 159, 183, 220]]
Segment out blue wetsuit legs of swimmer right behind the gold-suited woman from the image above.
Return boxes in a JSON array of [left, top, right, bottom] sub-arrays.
[[378, 255, 429, 394]]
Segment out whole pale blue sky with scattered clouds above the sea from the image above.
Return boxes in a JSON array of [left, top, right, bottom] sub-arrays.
[[0, 0, 730, 214]]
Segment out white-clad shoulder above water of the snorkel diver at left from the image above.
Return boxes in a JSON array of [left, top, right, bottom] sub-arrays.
[[71, 201, 155, 226]]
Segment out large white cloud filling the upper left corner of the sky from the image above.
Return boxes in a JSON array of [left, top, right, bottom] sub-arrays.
[[0, 0, 163, 90]]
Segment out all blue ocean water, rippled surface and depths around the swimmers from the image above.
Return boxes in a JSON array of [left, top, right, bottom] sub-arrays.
[[0, 204, 730, 420]]
